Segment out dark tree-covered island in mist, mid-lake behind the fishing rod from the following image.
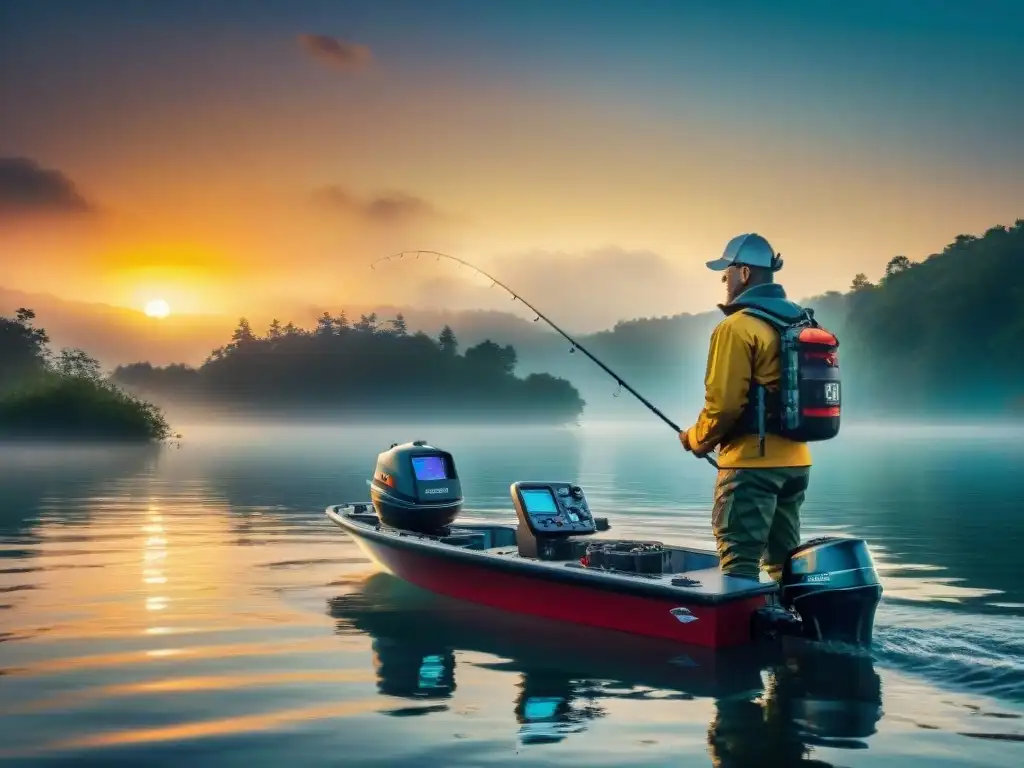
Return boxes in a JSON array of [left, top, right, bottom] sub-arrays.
[[113, 311, 585, 422]]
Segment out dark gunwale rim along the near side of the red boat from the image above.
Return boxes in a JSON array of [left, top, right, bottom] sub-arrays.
[[325, 502, 778, 606]]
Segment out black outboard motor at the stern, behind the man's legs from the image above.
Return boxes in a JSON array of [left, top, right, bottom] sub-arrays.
[[779, 537, 882, 645]]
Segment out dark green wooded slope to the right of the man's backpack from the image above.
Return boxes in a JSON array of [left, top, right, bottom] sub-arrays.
[[844, 219, 1024, 414]]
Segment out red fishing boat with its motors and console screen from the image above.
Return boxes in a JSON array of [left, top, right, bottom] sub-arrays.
[[326, 440, 882, 648]]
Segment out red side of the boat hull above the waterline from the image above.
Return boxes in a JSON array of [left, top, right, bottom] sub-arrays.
[[353, 534, 766, 648]]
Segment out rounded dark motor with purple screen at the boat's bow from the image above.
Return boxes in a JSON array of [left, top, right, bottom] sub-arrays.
[[368, 440, 463, 536]]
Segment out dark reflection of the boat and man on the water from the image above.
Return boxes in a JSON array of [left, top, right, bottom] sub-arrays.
[[328, 573, 882, 767]]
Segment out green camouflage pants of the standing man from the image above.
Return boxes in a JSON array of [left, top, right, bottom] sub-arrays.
[[712, 467, 811, 581]]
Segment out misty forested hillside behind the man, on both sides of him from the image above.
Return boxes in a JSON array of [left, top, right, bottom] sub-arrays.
[[512, 219, 1024, 423]]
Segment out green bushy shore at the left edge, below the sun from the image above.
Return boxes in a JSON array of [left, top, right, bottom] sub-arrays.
[[0, 309, 171, 440]]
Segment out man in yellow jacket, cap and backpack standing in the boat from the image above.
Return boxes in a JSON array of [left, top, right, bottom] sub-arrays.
[[679, 233, 839, 581]]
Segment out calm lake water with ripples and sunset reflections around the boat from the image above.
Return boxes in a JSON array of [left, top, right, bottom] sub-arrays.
[[0, 425, 1024, 768]]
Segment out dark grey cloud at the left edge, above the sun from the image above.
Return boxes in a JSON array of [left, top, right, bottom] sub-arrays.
[[0, 157, 95, 215]]
